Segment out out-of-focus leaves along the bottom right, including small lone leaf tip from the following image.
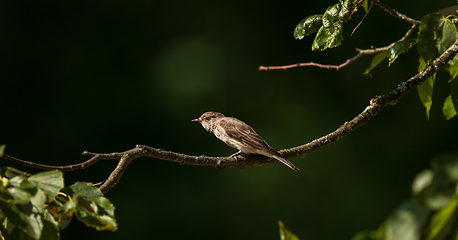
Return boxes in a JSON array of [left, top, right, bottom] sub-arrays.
[[279, 154, 458, 240]]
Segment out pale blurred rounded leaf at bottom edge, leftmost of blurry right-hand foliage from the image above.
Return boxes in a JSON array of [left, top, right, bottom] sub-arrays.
[[385, 201, 430, 240]]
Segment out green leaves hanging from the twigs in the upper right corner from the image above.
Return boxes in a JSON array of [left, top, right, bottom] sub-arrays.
[[294, 0, 458, 120]]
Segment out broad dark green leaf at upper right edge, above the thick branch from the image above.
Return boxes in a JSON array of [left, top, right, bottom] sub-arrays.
[[417, 13, 458, 63]]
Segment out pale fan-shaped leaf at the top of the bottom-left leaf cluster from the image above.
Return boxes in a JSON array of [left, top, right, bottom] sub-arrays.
[[29, 171, 64, 202]]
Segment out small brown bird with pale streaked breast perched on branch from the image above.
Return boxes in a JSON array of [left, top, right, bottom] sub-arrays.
[[192, 112, 299, 172]]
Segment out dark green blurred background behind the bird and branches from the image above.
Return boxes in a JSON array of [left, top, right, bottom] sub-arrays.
[[0, 0, 458, 240]]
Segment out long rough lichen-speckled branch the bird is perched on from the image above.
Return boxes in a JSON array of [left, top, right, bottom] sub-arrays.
[[3, 39, 458, 193]]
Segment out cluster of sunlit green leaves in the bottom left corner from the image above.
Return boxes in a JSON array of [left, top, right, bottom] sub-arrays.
[[0, 167, 117, 240]]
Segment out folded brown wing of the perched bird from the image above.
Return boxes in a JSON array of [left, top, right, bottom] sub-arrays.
[[219, 118, 278, 155]]
